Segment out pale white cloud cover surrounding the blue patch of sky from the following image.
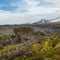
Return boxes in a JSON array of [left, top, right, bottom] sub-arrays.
[[0, 0, 60, 24]]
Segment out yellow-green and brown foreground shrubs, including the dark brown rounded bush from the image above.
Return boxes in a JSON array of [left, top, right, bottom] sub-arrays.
[[0, 27, 60, 60]]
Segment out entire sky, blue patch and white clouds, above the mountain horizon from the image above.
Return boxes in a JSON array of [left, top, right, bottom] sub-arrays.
[[0, 0, 60, 24]]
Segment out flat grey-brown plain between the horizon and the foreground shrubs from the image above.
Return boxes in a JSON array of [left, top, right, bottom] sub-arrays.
[[0, 24, 60, 36]]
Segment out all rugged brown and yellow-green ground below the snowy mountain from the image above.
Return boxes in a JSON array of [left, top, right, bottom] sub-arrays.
[[0, 24, 60, 60]]
